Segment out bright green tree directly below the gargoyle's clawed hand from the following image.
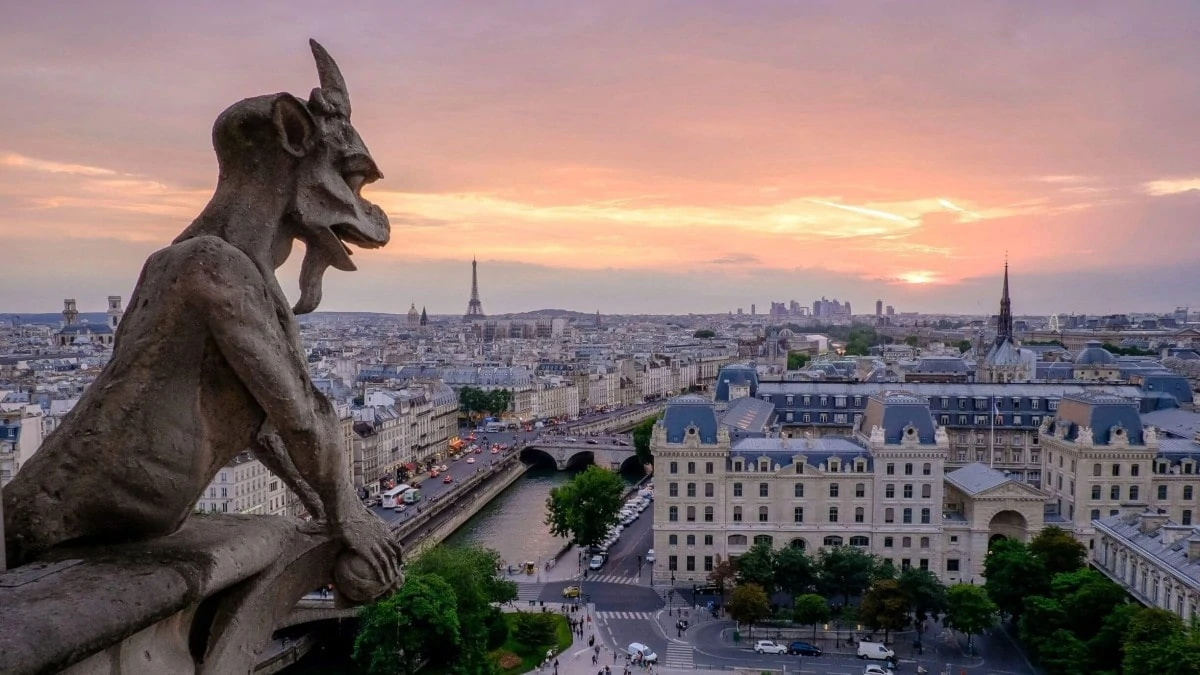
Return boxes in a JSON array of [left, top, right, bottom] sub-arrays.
[[352, 574, 461, 675]]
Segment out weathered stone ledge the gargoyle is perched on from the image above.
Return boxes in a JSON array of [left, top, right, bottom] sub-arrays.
[[0, 514, 340, 674]]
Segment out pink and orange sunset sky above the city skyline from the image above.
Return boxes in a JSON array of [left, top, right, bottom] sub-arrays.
[[0, 0, 1200, 313]]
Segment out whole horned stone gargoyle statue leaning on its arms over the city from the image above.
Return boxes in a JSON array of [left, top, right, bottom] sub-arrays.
[[4, 42, 403, 602]]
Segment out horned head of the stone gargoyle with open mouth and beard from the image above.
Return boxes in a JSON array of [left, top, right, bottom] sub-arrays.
[[212, 40, 391, 313]]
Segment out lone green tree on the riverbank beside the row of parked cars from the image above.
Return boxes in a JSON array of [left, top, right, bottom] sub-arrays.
[[546, 465, 625, 546]]
